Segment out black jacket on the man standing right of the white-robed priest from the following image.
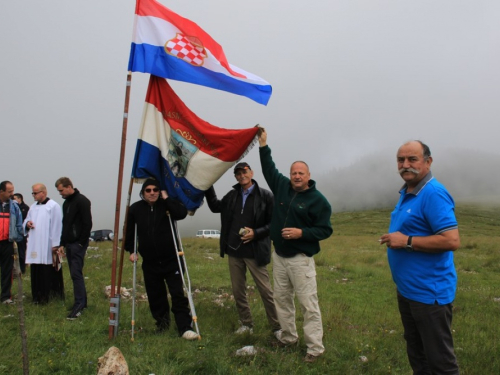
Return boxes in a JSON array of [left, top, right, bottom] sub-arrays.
[[61, 189, 92, 246]]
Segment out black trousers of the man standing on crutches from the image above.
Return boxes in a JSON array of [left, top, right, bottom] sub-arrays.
[[142, 260, 192, 335]]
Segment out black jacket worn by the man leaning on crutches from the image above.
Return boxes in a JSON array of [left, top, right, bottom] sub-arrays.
[[125, 197, 187, 261]]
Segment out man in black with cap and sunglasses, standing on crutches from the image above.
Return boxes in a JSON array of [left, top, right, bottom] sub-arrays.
[[125, 179, 198, 340]]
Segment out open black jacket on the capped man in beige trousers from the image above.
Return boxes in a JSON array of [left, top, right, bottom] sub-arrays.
[[205, 179, 274, 266]]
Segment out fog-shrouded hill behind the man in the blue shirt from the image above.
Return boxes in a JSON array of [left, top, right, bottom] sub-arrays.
[[313, 149, 500, 212]]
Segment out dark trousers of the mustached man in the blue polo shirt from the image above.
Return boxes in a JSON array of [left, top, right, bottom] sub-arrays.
[[398, 293, 459, 375]]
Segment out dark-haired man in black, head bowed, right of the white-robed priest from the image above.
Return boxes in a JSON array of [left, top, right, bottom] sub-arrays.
[[55, 177, 92, 320]]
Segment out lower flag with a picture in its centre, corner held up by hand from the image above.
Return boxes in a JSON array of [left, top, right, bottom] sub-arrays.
[[132, 75, 258, 213]]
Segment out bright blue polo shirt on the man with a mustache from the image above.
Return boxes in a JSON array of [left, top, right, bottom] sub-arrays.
[[387, 172, 458, 305]]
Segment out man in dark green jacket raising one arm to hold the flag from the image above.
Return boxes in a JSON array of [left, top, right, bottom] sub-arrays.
[[259, 128, 333, 362]]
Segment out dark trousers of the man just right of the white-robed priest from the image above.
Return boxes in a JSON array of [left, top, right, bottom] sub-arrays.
[[65, 242, 88, 308]]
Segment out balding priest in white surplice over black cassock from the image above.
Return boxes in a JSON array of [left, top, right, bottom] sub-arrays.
[[23, 183, 64, 304]]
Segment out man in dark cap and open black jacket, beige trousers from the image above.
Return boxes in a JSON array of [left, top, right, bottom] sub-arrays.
[[205, 163, 281, 337]]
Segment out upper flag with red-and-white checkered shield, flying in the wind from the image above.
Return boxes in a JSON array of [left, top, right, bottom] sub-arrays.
[[128, 0, 272, 105]]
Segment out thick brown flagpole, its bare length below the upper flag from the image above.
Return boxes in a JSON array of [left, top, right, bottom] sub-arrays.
[[109, 71, 132, 339]]
